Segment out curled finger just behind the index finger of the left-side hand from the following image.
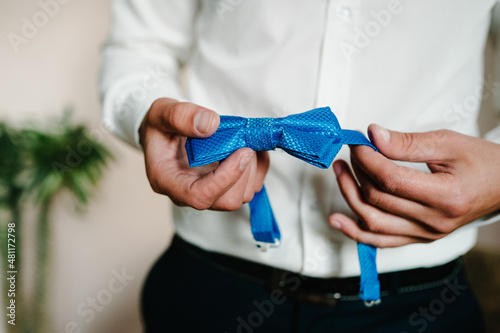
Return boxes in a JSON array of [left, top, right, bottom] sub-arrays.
[[210, 152, 256, 211]]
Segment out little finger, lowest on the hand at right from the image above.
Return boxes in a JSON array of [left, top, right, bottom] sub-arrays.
[[329, 214, 430, 248]]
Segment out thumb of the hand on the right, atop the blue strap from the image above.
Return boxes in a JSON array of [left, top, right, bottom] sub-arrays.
[[368, 124, 449, 162]]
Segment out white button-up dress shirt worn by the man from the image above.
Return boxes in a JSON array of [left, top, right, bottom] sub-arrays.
[[101, 0, 500, 277]]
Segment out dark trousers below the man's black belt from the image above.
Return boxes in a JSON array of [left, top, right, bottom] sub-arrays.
[[142, 236, 483, 333]]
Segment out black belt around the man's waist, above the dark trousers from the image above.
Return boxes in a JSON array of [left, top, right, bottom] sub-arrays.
[[170, 235, 462, 306]]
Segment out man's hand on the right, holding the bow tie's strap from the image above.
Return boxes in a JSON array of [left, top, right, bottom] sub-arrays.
[[329, 125, 500, 247]]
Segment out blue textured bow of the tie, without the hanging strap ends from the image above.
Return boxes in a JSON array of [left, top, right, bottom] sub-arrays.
[[186, 107, 356, 169]]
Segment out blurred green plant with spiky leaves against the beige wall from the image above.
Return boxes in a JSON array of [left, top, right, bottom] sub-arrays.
[[0, 113, 112, 333]]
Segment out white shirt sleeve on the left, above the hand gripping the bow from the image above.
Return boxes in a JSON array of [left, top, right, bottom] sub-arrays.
[[100, 0, 198, 149]]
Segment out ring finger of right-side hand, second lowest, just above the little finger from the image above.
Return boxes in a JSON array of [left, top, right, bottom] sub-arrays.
[[334, 161, 436, 238]]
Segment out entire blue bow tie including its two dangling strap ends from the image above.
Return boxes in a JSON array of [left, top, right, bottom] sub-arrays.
[[186, 107, 380, 306]]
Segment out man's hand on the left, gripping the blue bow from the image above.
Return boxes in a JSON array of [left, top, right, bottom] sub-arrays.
[[139, 98, 269, 211]]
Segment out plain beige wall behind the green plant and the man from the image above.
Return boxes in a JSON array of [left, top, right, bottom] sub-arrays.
[[0, 0, 500, 333]]
